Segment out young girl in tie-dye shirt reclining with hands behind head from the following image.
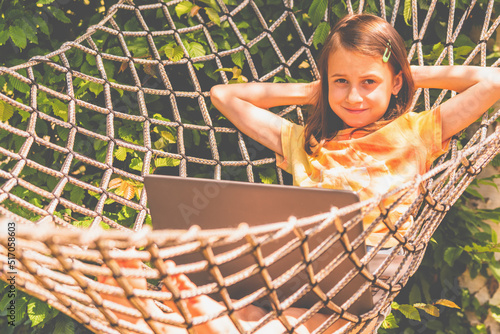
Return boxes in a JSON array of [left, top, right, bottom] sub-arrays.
[[98, 14, 500, 333]]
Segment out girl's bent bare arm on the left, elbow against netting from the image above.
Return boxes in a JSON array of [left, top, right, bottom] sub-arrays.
[[210, 82, 319, 154]]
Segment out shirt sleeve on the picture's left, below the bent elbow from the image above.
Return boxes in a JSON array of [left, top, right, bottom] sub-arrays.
[[276, 119, 304, 174]]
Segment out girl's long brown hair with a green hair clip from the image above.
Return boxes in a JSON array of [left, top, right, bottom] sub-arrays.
[[304, 14, 415, 154]]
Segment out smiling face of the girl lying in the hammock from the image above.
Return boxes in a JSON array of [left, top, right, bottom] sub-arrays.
[[327, 49, 403, 128]]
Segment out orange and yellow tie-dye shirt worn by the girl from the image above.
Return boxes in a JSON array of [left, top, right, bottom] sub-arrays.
[[277, 108, 446, 247]]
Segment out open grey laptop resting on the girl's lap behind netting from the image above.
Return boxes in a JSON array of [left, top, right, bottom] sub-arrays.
[[145, 175, 373, 315]]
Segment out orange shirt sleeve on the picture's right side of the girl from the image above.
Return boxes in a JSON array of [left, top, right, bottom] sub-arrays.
[[412, 107, 449, 169]]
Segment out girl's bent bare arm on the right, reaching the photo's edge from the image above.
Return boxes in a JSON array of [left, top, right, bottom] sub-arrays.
[[411, 66, 500, 141]]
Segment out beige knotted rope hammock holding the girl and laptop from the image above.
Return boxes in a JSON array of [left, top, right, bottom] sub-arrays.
[[0, 0, 500, 333]]
